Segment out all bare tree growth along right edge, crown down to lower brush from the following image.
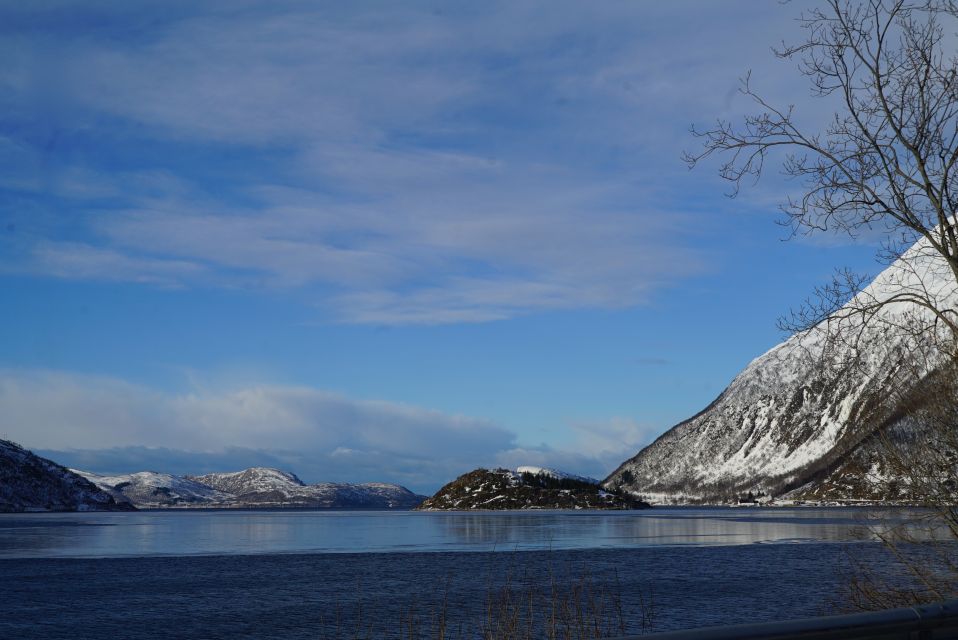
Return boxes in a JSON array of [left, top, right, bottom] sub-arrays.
[[684, 0, 958, 607]]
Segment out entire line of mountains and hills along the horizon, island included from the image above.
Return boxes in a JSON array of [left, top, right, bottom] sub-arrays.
[[9, 234, 958, 511]]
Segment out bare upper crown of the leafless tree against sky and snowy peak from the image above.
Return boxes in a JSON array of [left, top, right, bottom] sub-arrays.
[[684, 0, 958, 355]]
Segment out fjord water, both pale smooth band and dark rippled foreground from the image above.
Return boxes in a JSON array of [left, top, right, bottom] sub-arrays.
[[0, 508, 897, 639]]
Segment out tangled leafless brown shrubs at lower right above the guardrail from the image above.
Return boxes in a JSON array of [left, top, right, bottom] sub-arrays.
[[845, 365, 958, 609]]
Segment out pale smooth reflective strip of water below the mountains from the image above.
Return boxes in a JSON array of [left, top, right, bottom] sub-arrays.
[[0, 508, 928, 558]]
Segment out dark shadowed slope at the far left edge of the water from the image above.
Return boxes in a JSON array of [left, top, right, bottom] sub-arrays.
[[0, 440, 132, 512]]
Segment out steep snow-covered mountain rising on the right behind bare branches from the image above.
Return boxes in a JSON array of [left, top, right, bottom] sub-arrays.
[[603, 243, 958, 502]]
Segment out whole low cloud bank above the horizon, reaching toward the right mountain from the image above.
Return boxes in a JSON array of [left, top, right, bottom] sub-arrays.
[[0, 370, 647, 492]]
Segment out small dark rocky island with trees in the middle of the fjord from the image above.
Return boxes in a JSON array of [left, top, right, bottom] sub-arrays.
[[417, 467, 649, 511]]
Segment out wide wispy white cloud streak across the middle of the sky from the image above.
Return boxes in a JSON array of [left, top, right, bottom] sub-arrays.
[[7, 169, 705, 325]]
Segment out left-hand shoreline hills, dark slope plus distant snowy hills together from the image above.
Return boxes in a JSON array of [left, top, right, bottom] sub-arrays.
[[0, 440, 426, 512]]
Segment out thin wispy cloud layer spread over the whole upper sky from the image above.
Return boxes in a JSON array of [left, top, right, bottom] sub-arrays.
[[0, 3, 808, 324]]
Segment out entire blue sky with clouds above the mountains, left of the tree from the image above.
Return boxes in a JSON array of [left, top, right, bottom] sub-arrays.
[[0, 1, 877, 491]]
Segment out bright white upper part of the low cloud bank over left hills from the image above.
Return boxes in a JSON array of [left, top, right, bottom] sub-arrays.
[[0, 371, 514, 457]]
